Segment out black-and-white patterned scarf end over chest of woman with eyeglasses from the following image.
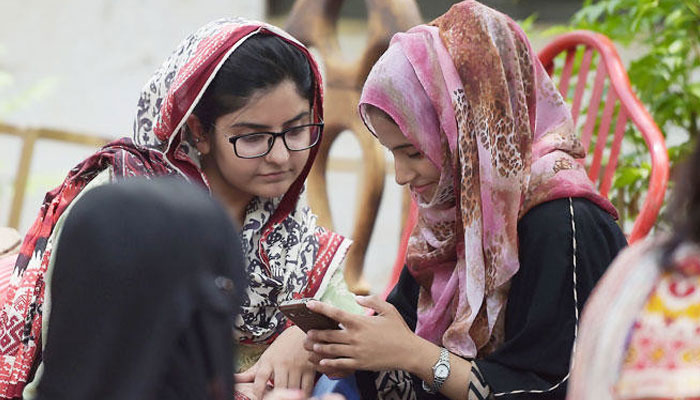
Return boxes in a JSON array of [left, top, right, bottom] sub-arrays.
[[235, 198, 350, 344]]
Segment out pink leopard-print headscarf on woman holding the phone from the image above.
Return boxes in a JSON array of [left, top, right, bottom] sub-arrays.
[[359, 1, 617, 358]]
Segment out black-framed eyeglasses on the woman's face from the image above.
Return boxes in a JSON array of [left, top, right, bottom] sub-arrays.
[[228, 122, 323, 158]]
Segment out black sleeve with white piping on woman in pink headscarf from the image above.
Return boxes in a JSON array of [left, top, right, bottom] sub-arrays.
[[476, 199, 626, 399]]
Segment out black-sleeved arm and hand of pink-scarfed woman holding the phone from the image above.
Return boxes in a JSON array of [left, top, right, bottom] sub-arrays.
[[305, 199, 625, 398]]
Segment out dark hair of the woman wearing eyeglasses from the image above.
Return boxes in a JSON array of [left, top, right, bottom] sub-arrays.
[[193, 33, 315, 130]]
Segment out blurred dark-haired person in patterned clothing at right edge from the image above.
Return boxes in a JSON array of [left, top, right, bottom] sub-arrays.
[[567, 146, 700, 400]]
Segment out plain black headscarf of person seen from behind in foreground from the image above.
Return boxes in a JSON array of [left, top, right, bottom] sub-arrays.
[[38, 179, 246, 400]]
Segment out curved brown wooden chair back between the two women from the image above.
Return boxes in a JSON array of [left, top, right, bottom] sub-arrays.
[[285, 0, 422, 294]]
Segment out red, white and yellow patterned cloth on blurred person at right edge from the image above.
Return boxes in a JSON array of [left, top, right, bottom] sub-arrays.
[[615, 260, 700, 399]]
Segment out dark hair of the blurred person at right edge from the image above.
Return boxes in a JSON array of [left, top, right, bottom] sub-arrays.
[[662, 140, 700, 268]]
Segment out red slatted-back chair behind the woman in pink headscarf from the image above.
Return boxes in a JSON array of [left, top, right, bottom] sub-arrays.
[[385, 31, 669, 295]]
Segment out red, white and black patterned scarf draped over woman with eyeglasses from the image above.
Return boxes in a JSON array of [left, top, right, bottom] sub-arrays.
[[0, 19, 349, 398]]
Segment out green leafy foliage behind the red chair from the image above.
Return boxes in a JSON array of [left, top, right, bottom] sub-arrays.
[[547, 0, 700, 228]]
